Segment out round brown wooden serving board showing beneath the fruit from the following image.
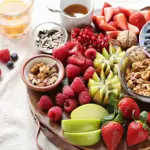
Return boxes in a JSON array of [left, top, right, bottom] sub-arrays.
[[27, 6, 150, 150]]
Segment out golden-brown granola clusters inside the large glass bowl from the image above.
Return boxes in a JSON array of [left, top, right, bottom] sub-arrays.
[[125, 58, 150, 96]]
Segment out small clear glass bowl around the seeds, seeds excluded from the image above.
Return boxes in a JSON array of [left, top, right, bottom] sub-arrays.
[[32, 22, 68, 54]]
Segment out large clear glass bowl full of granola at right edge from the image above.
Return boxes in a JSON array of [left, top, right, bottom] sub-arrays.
[[118, 46, 150, 103]]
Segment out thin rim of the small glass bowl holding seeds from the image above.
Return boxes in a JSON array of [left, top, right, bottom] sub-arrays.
[[32, 22, 68, 54]]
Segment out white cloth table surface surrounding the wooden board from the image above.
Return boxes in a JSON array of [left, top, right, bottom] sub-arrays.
[[0, 0, 150, 150]]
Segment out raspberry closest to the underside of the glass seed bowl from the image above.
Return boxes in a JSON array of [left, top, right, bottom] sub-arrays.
[[52, 45, 68, 62]]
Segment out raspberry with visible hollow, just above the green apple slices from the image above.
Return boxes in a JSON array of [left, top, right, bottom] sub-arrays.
[[64, 98, 77, 113]]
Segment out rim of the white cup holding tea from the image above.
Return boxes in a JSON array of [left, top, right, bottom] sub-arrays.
[[59, 0, 94, 20]]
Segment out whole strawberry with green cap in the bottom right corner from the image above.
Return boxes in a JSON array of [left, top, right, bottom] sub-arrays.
[[126, 111, 149, 146]]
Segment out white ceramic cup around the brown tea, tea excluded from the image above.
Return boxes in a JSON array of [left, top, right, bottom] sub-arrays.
[[60, 0, 94, 32]]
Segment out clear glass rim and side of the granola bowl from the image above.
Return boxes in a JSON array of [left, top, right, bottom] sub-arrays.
[[118, 46, 150, 103]]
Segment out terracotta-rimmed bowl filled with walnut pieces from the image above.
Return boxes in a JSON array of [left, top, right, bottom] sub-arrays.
[[21, 54, 64, 92]]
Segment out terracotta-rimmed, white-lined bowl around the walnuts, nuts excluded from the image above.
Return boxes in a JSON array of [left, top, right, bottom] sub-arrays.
[[21, 54, 65, 92]]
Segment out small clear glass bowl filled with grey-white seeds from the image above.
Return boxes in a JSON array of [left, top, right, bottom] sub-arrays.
[[33, 22, 68, 53]]
